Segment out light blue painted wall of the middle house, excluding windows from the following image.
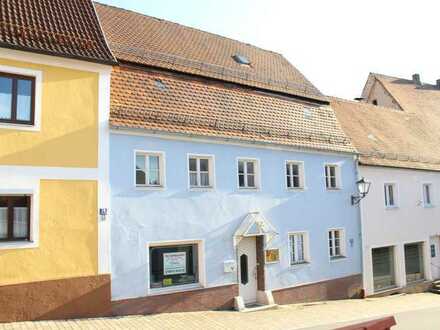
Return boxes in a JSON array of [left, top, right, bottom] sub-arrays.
[[110, 133, 361, 299]]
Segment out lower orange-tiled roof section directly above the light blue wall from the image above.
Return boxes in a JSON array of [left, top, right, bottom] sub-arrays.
[[110, 66, 354, 153]]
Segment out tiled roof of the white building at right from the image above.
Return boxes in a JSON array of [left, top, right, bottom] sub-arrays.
[[331, 98, 440, 171]]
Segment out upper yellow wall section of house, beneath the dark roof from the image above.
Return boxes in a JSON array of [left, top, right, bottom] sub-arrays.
[[0, 58, 99, 167]]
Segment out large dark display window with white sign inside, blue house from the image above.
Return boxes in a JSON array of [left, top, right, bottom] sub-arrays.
[[150, 244, 199, 289]]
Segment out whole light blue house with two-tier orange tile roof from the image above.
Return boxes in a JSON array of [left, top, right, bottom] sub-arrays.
[[97, 4, 362, 314]]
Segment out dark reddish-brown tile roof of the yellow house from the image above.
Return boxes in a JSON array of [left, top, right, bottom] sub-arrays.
[[0, 0, 115, 64]]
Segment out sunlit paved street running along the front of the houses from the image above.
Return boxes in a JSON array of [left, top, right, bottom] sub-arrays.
[[0, 293, 440, 330]]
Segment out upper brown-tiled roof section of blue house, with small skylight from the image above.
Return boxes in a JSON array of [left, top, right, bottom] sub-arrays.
[[96, 3, 327, 101]]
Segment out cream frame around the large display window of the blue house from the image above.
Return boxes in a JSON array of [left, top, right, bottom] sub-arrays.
[[146, 239, 206, 296]]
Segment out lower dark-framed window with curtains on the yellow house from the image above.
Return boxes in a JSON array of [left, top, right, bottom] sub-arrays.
[[0, 196, 31, 241]]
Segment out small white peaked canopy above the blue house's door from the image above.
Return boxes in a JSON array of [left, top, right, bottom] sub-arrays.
[[234, 212, 278, 246]]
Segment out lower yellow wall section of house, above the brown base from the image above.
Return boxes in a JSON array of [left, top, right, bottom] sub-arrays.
[[0, 180, 98, 285]]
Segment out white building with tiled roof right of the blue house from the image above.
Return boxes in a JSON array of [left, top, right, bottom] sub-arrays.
[[332, 74, 440, 295]]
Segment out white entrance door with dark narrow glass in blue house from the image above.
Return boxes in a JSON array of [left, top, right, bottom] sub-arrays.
[[238, 237, 257, 304]]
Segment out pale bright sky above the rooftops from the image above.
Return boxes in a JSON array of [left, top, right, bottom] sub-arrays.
[[98, 0, 440, 99]]
